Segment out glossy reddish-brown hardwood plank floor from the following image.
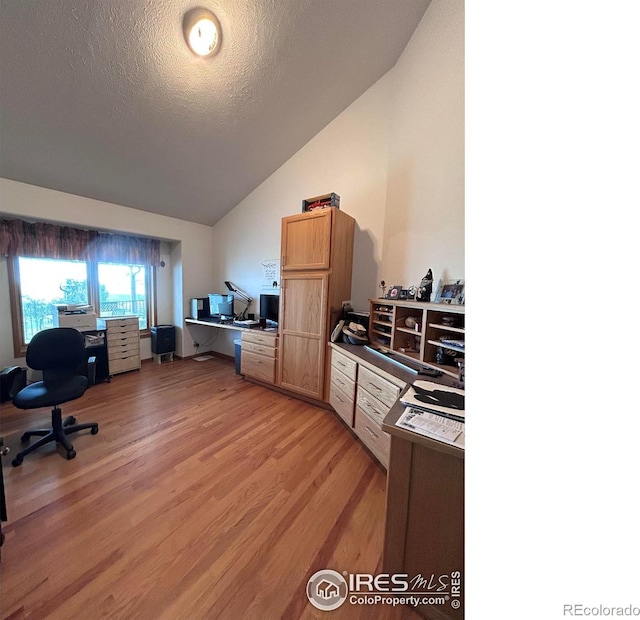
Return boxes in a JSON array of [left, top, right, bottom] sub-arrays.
[[0, 359, 418, 620]]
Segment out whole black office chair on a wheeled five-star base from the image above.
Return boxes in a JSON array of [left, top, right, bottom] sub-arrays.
[[11, 327, 98, 467]]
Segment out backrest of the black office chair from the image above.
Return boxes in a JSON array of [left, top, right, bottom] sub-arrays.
[[27, 327, 87, 383]]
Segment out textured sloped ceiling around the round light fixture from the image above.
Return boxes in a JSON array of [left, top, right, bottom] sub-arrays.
[[0, 0, 430, 225]]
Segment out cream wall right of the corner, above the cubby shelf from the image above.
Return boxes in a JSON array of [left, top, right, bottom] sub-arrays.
[[382, 0, 465, 286]]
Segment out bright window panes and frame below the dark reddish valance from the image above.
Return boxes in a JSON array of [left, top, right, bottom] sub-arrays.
[[10, 257, 155, 356]]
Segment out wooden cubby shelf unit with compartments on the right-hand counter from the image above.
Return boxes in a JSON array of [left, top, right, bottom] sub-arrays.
[[369, 299, 465, 378]]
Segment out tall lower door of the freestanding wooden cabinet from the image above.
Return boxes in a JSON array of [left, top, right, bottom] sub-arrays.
[[279, 272, 329, 400]]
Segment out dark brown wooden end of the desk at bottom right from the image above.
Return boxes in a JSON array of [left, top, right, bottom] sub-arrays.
[[382, 402, 464, 620]]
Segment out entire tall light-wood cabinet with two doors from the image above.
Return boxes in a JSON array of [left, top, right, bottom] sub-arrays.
[[278, 207, 355, 400]]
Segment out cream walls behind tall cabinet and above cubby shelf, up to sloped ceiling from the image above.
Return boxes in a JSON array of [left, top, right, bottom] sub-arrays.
[[213, 0, 464, 354]]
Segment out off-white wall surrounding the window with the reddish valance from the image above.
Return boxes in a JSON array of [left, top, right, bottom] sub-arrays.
[[0, 178, 215, 367]]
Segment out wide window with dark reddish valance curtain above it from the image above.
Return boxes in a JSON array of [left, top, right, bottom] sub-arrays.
[[0, 220, 160, 357]]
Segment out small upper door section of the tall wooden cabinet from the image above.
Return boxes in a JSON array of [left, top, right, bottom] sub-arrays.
[[280, 207, 344, 271]]
